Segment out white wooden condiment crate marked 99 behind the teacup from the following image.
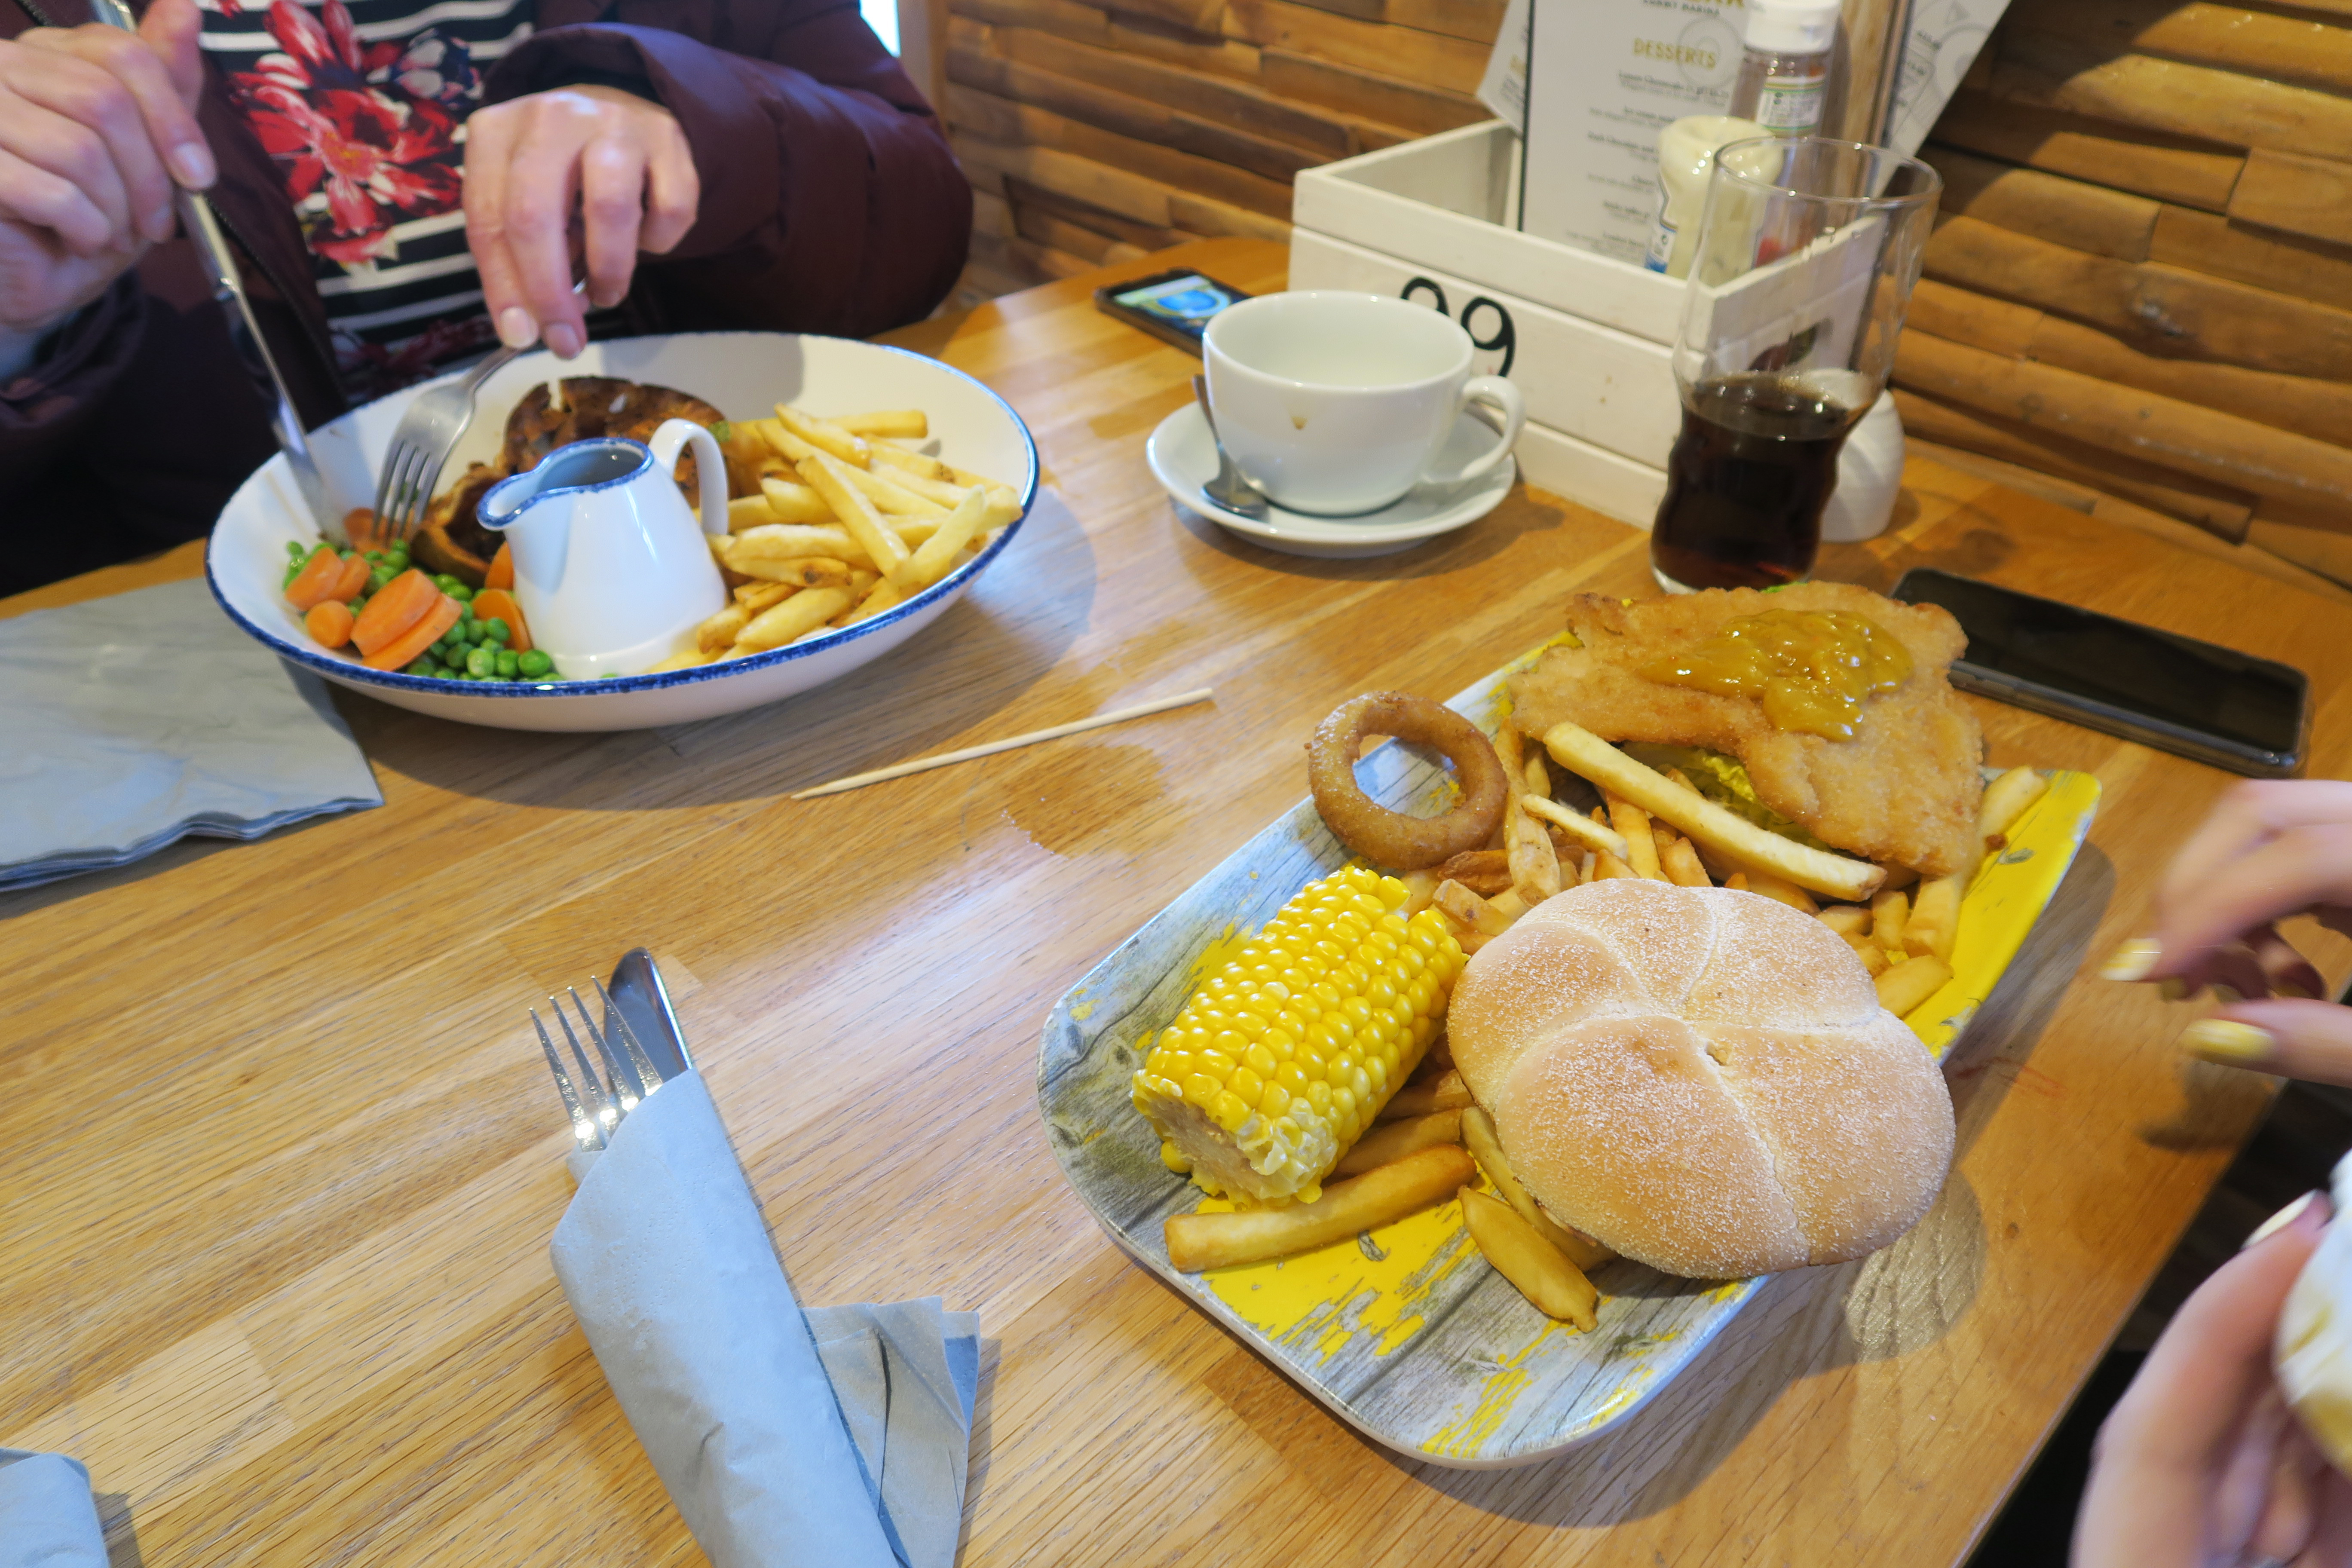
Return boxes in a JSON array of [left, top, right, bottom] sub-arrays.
[[1291, 120, 1684, 529]]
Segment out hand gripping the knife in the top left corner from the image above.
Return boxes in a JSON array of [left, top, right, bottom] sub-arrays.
[[0, 0, 214, 336]]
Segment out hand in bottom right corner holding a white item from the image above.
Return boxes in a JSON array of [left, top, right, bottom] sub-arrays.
[[2072, 1192, 2352, 1568]]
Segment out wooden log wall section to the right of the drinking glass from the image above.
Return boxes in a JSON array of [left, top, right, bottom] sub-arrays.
[[1896, 0, 2352, 583]]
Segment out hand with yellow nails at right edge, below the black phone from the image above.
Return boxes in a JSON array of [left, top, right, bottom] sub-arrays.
[[2103, 778, 2352, 1084]]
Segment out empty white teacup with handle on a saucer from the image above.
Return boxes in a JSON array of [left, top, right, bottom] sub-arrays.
[[1202, 289, 1526, 517]]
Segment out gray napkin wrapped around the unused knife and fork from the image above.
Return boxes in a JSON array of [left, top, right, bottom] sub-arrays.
[[555, 1072, 978, 1568]]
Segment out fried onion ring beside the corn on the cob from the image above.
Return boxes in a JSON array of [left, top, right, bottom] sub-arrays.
[[1308, 691, 1510, 872]]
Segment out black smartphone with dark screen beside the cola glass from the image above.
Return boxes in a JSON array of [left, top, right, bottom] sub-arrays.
[[1893, 567, 2310, 778]]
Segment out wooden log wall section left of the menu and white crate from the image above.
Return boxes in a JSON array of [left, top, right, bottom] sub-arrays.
[[941, 0, 1503, 303]]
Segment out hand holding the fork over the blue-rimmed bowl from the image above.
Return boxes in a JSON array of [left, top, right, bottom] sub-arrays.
[[466, 87, 701, 360]]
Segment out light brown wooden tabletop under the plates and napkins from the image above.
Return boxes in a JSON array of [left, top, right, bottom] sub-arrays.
[[0, 242, 2352, 1568]]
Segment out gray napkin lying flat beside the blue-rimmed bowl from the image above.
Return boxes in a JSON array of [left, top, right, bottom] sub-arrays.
[[0, 581, 383, 888]]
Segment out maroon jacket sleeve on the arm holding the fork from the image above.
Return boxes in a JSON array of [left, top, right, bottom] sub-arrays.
[[484, 0, 971, 336]]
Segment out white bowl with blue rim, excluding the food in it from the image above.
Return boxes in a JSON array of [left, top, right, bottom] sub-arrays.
[[205, 331, 1037, 731]]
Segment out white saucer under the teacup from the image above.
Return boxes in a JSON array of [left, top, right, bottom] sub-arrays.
[[1145, 402, 1519, 560]]
